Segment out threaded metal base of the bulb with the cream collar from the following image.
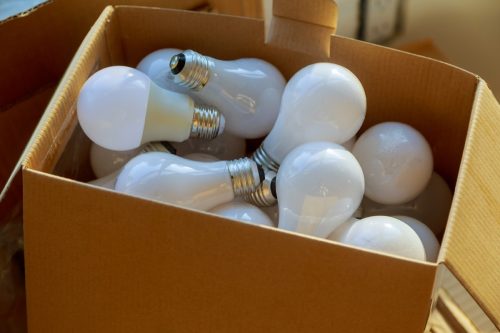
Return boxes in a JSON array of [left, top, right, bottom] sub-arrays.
[[190, 105, 224, 140]]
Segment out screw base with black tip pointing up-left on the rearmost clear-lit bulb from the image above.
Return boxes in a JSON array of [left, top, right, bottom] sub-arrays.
[[170, 50, 215, 90]]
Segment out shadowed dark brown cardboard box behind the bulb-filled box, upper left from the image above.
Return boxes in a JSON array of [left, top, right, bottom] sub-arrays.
[[0, 0, 262, 225]]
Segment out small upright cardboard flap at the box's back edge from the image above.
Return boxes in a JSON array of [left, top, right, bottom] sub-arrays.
[[266, 0, 337, 57]]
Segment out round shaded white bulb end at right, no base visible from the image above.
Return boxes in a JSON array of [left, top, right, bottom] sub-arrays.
[[353, 122, 433, 204]]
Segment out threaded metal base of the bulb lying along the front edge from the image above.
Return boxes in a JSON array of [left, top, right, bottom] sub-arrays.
[[227, 157, 260, 197]]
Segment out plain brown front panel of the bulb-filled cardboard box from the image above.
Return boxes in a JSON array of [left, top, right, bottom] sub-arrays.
[[23, 169, 436, 333]]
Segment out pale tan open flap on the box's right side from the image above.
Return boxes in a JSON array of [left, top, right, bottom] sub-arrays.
[[440, 80, 500, 328]]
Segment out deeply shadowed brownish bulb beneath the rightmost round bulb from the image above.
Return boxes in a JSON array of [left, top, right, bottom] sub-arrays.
[[361, 172, 453, 235]]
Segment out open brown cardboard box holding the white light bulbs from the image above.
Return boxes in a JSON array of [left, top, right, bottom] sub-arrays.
[[19, 0, 500, 333]]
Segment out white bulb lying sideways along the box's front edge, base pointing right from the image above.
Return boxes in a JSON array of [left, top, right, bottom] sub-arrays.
[[115, 152, 264, 210]]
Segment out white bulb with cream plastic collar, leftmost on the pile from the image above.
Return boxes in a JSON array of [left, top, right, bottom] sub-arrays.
[[77, 66, 224, 150]]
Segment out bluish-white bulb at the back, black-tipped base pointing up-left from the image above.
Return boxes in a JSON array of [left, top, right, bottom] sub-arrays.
[[170, 50, 285, 139]]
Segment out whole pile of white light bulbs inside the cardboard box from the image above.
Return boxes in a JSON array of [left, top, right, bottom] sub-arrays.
[[77, 49, 451, 261]]
